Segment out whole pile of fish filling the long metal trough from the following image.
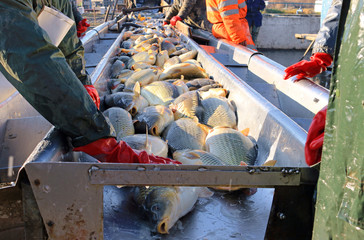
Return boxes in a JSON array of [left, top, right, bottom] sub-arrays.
[[102, 12, 266, 234]]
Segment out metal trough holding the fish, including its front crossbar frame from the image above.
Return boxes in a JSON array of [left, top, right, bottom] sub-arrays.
[[0, 16, 318, 239]]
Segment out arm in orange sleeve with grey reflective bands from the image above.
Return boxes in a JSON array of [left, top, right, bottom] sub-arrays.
[[218, 0, 250, 44]]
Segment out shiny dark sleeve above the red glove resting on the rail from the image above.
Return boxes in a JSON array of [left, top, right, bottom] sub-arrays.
[[312, 0, 342, 56]]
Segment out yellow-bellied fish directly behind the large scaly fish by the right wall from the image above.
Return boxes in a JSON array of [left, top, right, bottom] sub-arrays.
[[201, 97, 237, 128]]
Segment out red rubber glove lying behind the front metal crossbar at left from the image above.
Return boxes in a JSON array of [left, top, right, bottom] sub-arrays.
[[73, 138, 181, 164]]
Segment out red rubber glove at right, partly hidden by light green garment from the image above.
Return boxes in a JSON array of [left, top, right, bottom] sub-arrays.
[[305, 106, 327, 166]]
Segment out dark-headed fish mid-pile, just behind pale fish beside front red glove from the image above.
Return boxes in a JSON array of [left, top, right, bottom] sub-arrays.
[[134, 105, 174, 136]]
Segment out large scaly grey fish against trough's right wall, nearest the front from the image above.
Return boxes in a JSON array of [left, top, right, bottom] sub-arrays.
[[206, 127, 258, 165]]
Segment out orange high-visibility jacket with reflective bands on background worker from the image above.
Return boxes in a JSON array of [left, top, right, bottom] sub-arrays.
[[206, 0, 255, 46]]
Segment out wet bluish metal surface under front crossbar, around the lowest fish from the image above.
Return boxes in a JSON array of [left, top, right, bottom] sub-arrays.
[[104, 186, 274, 240]]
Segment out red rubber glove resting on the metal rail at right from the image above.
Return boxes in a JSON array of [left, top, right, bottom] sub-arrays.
[[283, 53, 332, 80]]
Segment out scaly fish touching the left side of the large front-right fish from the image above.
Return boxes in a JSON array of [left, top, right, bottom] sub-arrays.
[[162, 118, 209, 153]]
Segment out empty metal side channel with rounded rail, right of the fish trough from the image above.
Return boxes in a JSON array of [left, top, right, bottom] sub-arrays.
[[193, 30, 329, 130]]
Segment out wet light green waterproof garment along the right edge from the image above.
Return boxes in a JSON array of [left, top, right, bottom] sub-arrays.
[[313, 0, 364, 240]]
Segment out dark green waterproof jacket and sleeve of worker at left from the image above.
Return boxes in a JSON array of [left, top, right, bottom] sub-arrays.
[[0, 0, 115, 146]]
